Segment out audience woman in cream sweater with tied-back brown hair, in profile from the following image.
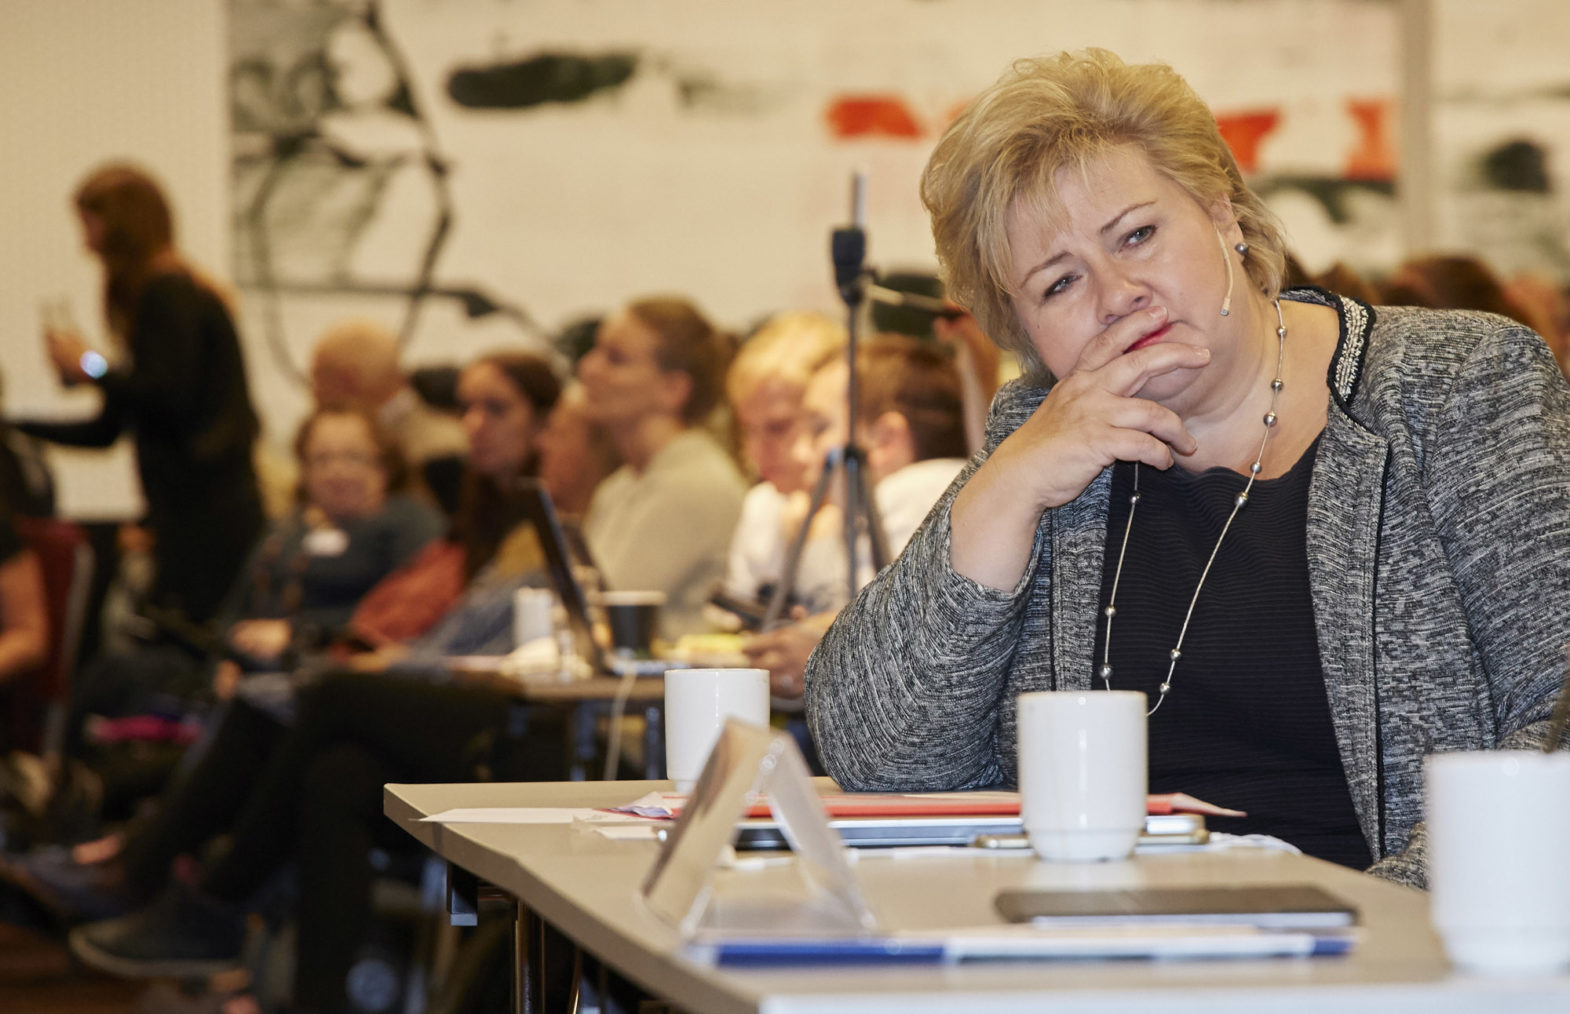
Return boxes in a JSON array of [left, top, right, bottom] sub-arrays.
[[578, 298, 746, 640]]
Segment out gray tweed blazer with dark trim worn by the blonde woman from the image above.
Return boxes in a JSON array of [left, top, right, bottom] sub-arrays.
[[805, 289, 1570, 887]]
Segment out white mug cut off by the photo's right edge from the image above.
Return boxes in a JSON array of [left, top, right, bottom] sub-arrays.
[[1424, 750, 1570, 975]]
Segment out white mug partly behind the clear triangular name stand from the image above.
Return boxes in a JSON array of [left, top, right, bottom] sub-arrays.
[[666, 669, 769, 793]]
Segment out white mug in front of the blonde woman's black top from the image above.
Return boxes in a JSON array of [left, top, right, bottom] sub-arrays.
[[1019, 691, 1148, 862]]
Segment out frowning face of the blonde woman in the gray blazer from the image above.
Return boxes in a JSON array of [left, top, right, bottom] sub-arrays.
[[1008, 148, 1251, 407]]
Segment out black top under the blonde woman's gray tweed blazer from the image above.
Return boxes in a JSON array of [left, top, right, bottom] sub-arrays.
[[1094, 441, 1372, 868]]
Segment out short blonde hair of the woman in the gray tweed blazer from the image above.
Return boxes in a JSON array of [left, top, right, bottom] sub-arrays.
[[922, 49, 1286, 367]]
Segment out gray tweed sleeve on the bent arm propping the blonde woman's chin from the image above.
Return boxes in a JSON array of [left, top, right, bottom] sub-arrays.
[[805, 381, 1049, 791]]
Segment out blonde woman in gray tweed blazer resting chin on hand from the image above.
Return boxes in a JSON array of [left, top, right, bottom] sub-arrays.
[[807, 50, 1570, 885]]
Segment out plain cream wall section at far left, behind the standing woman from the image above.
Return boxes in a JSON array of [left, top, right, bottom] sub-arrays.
[[0, 0, 229, 516]]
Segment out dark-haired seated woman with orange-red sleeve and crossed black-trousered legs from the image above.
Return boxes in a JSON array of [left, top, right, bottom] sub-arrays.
[[5, 353, 589, 1011]]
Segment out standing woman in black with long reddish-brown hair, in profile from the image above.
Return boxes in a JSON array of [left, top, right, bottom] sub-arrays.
[[17, 165, 262, 622]]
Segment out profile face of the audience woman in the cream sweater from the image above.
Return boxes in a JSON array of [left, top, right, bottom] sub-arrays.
[[578, 311, 691, 430]]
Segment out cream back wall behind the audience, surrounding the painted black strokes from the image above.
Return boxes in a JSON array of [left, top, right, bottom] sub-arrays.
[[12, 0, 1570, 516]]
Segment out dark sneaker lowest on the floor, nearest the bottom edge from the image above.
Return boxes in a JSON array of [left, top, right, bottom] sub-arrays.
[[69, 884, 245, 978]]
